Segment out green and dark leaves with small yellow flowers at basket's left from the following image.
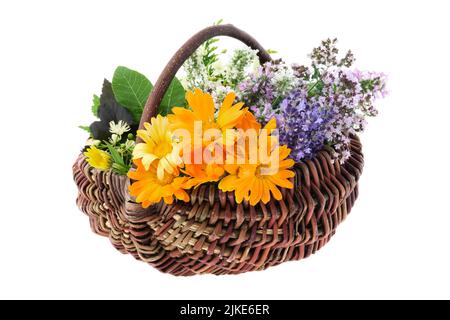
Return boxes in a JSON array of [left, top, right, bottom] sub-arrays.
[[79, 66, 186, 175]]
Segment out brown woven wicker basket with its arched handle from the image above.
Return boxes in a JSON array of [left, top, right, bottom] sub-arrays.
[[73, 25, 363, 276]]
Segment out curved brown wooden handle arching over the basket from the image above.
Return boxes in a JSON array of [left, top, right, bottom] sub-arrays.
[[138, 24, 272, 132]]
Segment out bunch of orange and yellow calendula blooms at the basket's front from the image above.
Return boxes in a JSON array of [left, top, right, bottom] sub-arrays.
[[128, 89, 294, 207]]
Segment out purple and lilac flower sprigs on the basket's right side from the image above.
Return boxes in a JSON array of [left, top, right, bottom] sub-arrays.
[[239, 39, 386, 162]]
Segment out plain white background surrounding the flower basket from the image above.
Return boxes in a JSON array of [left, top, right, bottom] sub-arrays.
[[0, 0, 450, 299]]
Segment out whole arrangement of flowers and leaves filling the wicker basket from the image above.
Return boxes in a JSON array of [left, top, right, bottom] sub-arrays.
[[78, 26, 387, 207]]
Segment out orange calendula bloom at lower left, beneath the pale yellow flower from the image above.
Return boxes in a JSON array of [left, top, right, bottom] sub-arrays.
[[128, 159, 189, 208]]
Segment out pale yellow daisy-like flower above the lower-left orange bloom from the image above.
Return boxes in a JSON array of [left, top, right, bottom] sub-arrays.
[[133, 115, 182, 179]]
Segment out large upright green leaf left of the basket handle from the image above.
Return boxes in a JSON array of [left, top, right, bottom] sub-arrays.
[[112, 67, 153, 122]]
